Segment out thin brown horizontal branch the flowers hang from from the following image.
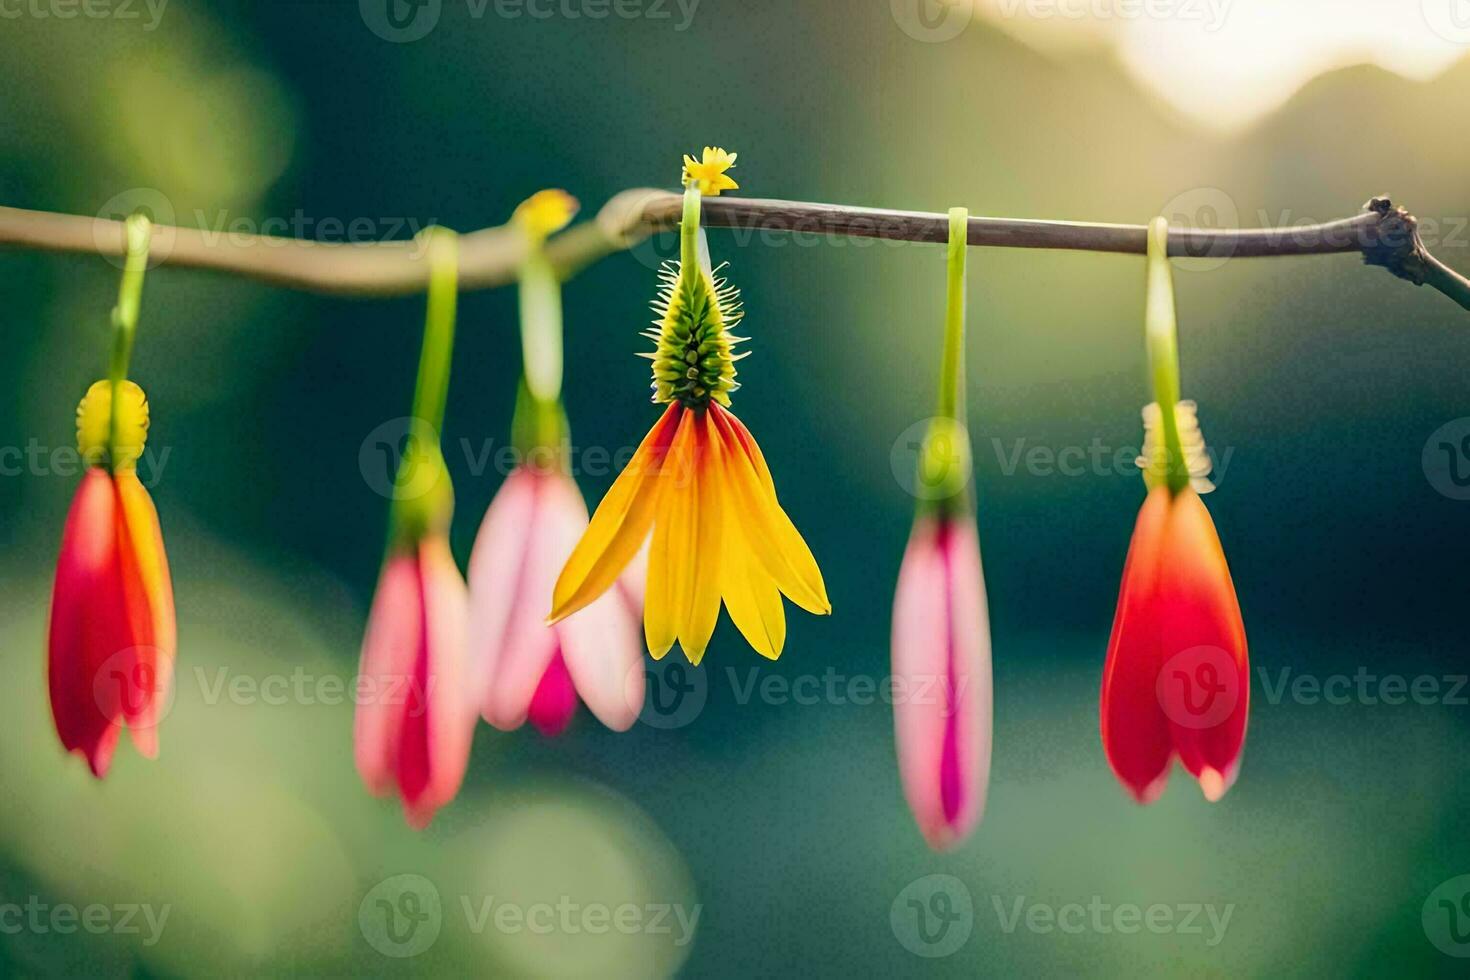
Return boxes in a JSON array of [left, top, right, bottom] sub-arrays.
[[0, 190, 1470, 310]]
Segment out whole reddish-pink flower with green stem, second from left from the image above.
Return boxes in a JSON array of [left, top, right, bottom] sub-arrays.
[[353, 228, 475, 829]]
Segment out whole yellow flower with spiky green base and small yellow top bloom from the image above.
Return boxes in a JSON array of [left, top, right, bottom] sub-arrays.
[[551, 148, 832, 664]]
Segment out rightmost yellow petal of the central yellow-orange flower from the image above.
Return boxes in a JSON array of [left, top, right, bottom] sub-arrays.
[[711, 408, 832, 616]]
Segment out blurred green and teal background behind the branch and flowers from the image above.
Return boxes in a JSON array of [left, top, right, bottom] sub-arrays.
[[0, 0, 1470, 977]]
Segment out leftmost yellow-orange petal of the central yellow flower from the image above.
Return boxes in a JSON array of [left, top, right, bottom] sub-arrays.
[[548, 404, 685, 623]]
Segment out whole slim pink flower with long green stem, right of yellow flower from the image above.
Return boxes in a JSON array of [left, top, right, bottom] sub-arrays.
[[892, 207, 991, 849]]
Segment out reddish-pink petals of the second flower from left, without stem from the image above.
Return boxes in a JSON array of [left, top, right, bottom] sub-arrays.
[[354, 532, 475, 830]]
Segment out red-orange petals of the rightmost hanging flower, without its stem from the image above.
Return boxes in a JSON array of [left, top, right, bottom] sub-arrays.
[[1101, 486, 1251, 804]]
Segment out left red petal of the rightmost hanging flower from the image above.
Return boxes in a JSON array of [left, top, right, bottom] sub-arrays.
[[1101, 488, 1173, 804]]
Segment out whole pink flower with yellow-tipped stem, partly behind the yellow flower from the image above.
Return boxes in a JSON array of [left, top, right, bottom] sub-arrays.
[[469, 191, 644, 735]]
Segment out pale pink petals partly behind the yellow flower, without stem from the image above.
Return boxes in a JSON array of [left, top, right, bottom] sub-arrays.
[[469, 466, 644, 735]]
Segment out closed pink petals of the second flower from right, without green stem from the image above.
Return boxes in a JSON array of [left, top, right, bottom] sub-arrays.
[[892, 514, 991, 851]]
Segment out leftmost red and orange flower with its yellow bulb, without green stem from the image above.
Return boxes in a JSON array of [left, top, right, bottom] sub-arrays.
[[47, 381, 176, 779]]
